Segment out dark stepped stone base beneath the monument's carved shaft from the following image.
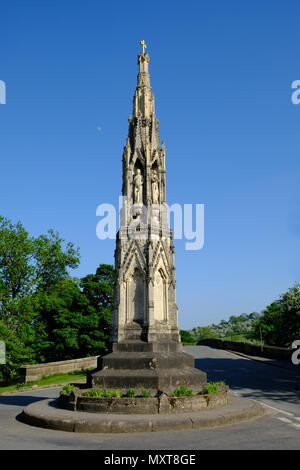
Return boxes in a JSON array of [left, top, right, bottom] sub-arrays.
[[87, 341, 207, 396]]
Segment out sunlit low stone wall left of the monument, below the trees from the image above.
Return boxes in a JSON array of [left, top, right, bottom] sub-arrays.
[[20, 356, 98, 382]]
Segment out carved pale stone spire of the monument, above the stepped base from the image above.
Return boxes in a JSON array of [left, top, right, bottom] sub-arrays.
[[113, 41, 175, 343]]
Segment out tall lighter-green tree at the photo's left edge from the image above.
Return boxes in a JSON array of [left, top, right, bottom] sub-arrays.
[[0, 216, 79, 375]]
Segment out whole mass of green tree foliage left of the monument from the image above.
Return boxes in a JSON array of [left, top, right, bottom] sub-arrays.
[[0, 216, 114, 376]]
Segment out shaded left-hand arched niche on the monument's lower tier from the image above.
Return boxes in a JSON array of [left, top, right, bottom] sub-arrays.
[[129, 268, 145, 325]]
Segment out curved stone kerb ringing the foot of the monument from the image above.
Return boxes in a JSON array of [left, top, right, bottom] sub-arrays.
[[18, 397, 265, 433]]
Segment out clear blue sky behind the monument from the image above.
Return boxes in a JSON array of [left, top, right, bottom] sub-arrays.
[[0, 0, 300, 328]]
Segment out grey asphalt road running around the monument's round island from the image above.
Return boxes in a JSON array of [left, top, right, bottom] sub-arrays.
[[0, 346, 300, 450]]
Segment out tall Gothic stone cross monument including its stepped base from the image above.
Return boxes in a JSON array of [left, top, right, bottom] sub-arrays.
[[88, 41, 206, 393]]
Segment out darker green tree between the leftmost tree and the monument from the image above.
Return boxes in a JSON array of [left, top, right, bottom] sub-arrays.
[[35, 265, 114, 361]]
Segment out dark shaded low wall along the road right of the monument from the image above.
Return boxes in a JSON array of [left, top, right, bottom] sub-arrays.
[[197, 338, 295, 361]]
